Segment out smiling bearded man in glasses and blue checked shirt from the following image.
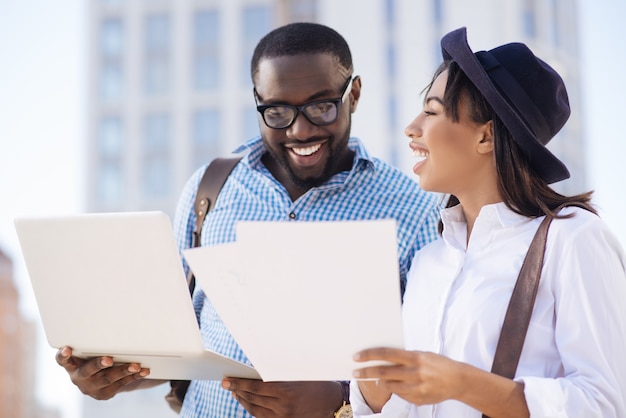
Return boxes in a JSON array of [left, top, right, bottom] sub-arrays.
[[57, 23, 437, 418]]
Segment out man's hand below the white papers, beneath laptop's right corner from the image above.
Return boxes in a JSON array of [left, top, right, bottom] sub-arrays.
[[222, 377, 343, 418]]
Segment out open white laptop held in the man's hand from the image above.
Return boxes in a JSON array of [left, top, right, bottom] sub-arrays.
[[14, 212, 260, 380]]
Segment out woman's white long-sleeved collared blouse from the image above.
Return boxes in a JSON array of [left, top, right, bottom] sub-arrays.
[[351, 203, 626, 418]]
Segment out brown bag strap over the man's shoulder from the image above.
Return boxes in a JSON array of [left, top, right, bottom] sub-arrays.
[[187, 158, 241, 295]]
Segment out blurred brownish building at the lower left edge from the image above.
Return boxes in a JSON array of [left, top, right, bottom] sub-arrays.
[[0, 250, 60, 418]]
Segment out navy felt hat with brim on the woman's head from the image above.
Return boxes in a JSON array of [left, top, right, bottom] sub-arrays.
[[441, 27, 570, 183]]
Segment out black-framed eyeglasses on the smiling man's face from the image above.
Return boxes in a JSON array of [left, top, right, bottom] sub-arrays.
[[253, 76, 353, 129]]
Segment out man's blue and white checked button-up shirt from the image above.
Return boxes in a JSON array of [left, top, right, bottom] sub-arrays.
[[174, 137, 438, 418]]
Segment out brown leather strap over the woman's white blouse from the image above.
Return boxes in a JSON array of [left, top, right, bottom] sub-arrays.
[[483, 216, 554, 418]]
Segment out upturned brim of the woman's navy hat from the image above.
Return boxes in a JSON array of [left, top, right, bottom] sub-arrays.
[[441, 27, 570, 183]]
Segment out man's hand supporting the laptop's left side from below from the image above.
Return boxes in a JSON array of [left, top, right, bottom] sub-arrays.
[[56, 347, 151, 400]]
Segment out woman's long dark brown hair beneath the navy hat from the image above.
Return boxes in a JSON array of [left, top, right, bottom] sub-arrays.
[[426, 61, 597, 230]]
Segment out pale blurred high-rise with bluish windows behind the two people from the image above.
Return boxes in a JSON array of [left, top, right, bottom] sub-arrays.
[[84, 0, 585, 418]]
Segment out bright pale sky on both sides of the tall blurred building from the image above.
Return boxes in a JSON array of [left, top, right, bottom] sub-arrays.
[[0, 0, 626, 418]]
